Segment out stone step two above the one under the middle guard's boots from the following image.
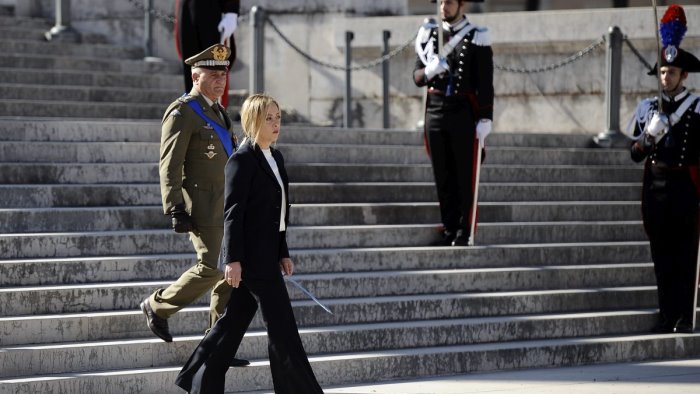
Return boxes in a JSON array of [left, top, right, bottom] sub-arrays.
[[0, 201, 641, 234]]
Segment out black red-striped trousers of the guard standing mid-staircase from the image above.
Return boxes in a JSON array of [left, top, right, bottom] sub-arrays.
[[425, 94, 478, 235]]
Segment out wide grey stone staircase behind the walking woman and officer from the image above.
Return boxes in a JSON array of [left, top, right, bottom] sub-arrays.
[[0, 6, 700, 394]]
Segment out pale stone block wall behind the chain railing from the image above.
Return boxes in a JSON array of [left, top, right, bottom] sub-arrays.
[[15, 0, 700, 133]]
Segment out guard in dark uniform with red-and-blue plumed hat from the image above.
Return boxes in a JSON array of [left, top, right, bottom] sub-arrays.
[[631, 6, 700, 333]]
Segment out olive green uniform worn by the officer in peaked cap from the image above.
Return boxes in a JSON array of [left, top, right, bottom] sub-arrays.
[[149, 90, 235, 326]]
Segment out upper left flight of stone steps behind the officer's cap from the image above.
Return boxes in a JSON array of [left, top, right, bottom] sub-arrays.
[[0, 15, 183, 119]]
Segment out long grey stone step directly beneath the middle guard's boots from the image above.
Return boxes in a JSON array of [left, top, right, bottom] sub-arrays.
[[0, 241, 651, 286]]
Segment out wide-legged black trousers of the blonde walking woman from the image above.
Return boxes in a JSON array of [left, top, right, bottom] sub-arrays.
[[175, 275, 323, 394]]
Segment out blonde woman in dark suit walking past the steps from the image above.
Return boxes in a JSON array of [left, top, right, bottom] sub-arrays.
[[176, 95, 323, 394]]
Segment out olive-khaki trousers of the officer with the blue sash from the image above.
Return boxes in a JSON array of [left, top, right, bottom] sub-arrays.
[[149, 226, 231, 327]]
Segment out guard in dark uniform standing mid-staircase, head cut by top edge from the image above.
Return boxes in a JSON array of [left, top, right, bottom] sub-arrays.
[[413, 0, 494, 246]]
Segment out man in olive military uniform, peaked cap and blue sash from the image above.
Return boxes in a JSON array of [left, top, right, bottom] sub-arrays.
[[141, 44, 249, 366]]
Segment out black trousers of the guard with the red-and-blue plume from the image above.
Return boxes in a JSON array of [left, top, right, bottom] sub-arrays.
[[642, 163, 698, 324]]
